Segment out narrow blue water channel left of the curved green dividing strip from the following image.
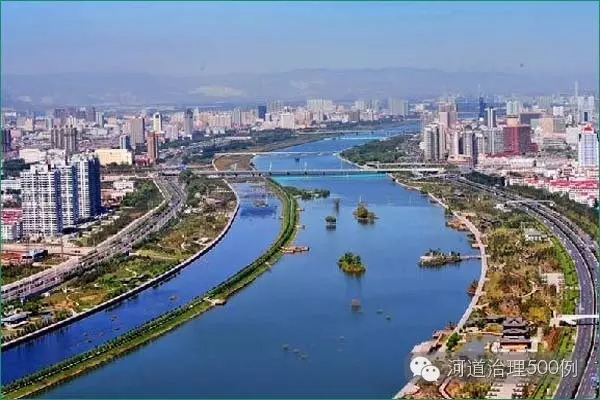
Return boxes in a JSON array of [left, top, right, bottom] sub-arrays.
[[2, 184, 280, 383]]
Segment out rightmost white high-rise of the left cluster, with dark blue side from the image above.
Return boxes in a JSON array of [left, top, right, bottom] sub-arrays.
[[70, 153, 102, 220]]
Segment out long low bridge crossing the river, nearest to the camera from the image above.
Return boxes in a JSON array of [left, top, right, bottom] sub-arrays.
[[162, 167, 444, 178]]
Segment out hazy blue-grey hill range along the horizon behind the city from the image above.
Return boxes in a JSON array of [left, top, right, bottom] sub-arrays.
[[2, 68, 598, 107]]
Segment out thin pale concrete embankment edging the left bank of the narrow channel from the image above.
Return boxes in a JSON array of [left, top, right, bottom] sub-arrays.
[[2, 182, 240, 350]]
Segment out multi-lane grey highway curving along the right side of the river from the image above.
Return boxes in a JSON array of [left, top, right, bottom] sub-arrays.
[[459, 178, 598, 399]]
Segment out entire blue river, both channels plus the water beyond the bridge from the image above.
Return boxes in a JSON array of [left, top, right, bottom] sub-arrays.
[[2, 125, 480, 398]]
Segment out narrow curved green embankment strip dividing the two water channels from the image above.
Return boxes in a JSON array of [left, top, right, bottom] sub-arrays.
[[2, 181, 299, 398]]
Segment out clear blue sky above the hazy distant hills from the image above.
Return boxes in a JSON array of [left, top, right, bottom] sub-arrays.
[[1, 1, 599, 76]]
